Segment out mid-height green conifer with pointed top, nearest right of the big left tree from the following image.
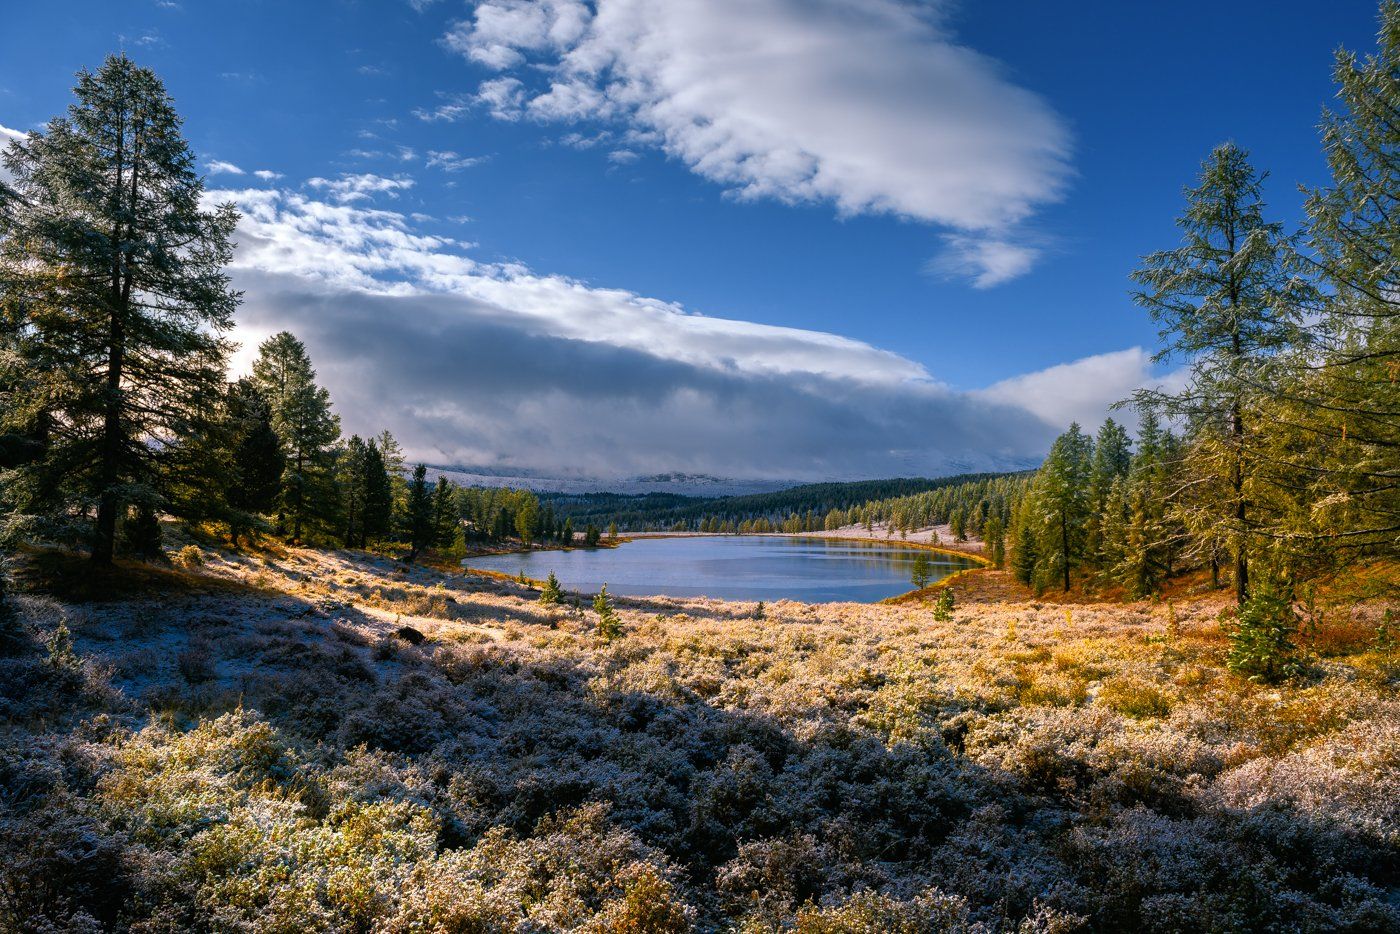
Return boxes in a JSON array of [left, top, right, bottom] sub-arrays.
[[252, 330, 340, 542]]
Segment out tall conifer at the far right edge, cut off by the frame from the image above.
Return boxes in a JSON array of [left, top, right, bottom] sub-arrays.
[[1293, 1, 1400, 571]]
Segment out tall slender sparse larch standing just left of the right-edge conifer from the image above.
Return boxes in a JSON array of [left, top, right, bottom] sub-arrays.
[[1133, 143, 1316, 602]]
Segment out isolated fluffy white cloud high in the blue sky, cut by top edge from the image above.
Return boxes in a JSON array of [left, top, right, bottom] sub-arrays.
[[445, 0, 1070, 287]]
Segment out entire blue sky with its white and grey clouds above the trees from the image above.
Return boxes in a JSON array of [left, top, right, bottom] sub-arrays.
[[0, 0, 1376, 480]]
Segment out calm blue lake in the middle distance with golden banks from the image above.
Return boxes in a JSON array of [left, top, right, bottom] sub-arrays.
[[463, 535, 977, 604]]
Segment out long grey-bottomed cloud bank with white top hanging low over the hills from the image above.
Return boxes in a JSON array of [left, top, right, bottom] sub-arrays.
[[209, 183, 1148, 479]]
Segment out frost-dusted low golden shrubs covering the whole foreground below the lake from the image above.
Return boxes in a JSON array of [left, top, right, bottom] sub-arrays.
[[0, 549, 1400, 934]]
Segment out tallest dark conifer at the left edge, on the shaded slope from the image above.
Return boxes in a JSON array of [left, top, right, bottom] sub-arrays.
[[0, 55, 238, 564]]
